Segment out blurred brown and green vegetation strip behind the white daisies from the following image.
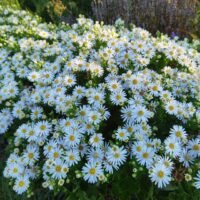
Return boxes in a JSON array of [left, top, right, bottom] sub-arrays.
[[0, 0, 200, 39]]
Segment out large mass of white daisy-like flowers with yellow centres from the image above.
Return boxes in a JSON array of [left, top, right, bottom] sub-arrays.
[[0, 8, 200, 198]]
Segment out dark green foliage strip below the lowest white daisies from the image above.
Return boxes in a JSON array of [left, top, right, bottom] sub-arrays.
[[0, 157, 200, 200]]
